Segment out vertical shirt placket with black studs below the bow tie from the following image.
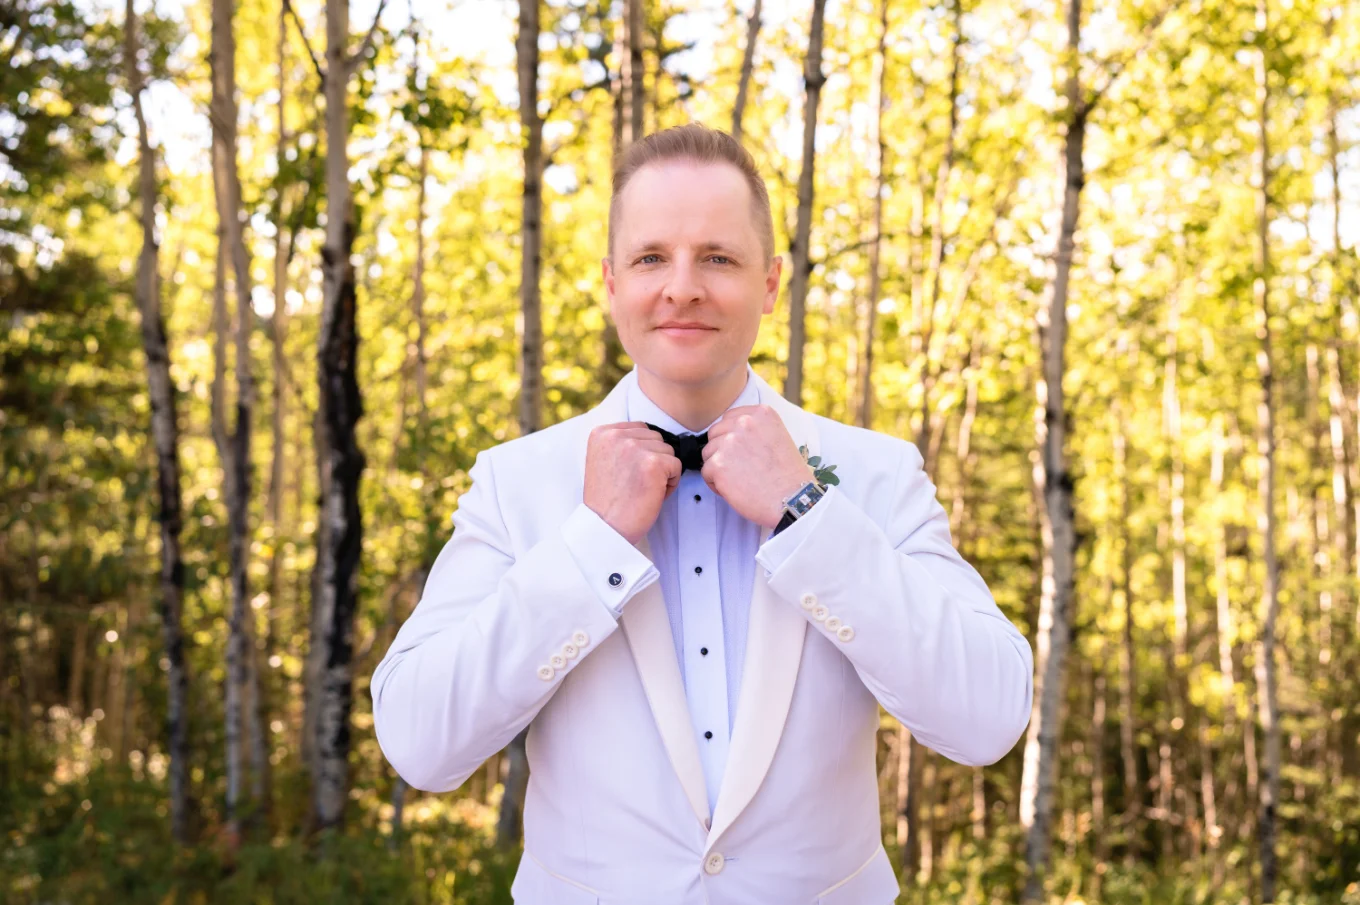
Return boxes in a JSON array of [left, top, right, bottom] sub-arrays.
[[676, 462, 729, 807]]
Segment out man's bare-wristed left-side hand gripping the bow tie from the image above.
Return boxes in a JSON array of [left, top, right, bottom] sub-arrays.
[[585, 421, 680, 543]]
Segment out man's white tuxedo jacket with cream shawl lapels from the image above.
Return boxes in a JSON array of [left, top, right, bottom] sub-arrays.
[[371, 372, 1032, 905]]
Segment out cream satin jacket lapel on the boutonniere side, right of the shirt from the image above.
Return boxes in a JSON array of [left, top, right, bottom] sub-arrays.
[[701, 376, 820, 848]]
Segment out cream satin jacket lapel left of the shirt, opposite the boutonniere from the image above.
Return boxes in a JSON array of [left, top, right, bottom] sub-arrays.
[[577, 370, 709, 827]]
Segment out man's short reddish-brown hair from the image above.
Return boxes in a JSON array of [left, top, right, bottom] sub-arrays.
[[609, 122, 774, 264]]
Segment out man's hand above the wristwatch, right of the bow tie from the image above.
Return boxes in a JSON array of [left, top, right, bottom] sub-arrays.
[[703, 406, 812, 528]]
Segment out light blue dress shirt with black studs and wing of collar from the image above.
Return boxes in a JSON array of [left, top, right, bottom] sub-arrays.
[[628, 366, 760, 810]]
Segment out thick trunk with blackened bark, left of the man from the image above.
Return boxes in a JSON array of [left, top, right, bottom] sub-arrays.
[[311, 0, 369, 830]]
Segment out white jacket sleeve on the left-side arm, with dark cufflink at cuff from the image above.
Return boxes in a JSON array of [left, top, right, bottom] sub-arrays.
[[371, 452, 658, 792]]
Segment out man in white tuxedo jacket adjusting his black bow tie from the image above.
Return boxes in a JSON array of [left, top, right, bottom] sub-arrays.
[[373, 125, 1032, 905]]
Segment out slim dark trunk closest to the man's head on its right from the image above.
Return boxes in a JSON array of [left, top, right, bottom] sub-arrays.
[[783, 0, 827, 406]]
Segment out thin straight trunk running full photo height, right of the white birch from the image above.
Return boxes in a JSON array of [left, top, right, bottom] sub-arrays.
[[1253, 0, 1280, 887]]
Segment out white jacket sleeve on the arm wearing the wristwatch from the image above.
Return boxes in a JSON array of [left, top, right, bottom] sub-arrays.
[[756, 444, 1034, 766]]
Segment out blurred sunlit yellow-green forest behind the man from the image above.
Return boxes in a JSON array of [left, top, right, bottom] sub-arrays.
[[0, 0, 1360, 905]]
